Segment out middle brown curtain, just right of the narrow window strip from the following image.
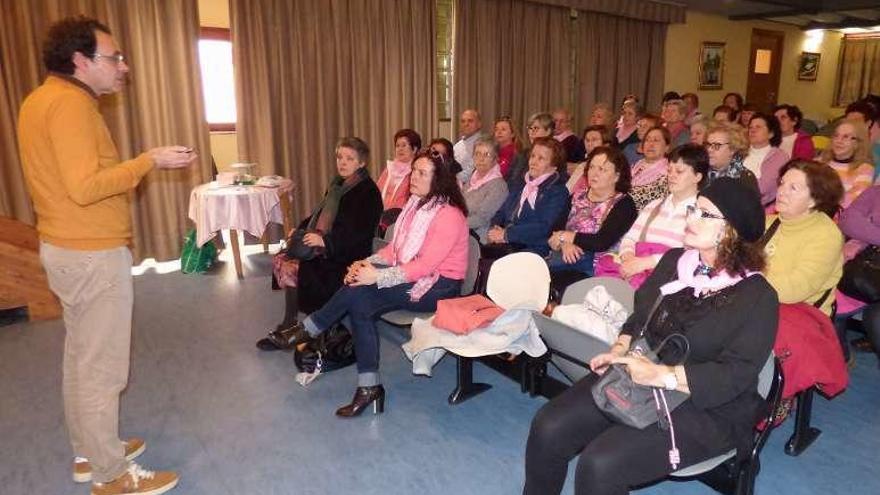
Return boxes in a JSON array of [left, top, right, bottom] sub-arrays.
[[452, 0, 572, 141]]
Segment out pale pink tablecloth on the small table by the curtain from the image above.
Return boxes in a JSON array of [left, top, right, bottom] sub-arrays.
[[189, 182, 289, 246]]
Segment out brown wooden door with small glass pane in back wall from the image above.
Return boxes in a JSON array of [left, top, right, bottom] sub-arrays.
[[746, 29, 785, 112]]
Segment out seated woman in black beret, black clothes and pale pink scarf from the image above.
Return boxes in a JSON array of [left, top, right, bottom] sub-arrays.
[[523, 179, 779, 495]]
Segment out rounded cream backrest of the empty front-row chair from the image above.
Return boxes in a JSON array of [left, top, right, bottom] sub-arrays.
[[486, 253, 550, 311]]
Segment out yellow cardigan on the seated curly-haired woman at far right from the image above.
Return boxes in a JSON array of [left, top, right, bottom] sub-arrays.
[[765, 211, 843, 314]]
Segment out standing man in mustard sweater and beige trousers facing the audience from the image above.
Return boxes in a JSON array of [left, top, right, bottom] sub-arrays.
[[18, 17, 196, 495]]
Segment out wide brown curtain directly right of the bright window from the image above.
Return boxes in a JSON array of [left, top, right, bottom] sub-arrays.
[[230, 0, 437, 221]]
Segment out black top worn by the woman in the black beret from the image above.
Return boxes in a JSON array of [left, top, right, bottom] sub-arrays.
[[621, 248, 779, 464]]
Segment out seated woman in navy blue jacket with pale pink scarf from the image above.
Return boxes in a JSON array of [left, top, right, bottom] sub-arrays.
[[484, 137, 569, 257]]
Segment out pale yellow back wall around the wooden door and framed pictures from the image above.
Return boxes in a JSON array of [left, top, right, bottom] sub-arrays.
[[664, 12, 843, 120]]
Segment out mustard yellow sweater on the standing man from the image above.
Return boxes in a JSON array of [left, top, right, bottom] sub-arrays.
[[18, 75, 153, 250]]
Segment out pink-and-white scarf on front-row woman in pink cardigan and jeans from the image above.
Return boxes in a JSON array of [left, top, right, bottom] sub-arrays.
[[391, 196, 446, 302]]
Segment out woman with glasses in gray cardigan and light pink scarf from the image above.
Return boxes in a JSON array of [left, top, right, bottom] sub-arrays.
[[461, 138, 507, 244]]
